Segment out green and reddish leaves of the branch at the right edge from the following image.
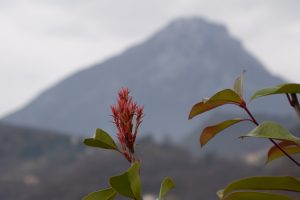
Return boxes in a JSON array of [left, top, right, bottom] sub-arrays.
[[189, 72, 300, 200]]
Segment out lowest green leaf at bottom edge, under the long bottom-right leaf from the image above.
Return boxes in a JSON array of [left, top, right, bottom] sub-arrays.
[[222, 192, 292, 200]]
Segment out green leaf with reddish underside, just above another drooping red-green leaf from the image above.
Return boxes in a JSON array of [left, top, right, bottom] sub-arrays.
[[189, 89, 243, 119]]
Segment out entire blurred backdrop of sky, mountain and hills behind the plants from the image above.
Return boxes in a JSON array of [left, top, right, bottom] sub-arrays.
[[0, 0, 300, 200]]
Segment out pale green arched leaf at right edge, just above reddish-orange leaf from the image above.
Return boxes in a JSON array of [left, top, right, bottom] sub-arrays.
[[241, 121, 300, 144]]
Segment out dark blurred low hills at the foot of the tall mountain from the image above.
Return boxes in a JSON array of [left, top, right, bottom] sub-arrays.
[[0, 123, 299, 200]]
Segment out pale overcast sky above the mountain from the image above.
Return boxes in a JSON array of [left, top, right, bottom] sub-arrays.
[[0, 0, 300, 116]]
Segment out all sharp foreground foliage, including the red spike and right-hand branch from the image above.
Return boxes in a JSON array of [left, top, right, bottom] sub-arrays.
[[83, 71, 300, 200]]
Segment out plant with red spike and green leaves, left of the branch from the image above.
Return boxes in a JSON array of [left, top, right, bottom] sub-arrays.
[[83, 88, 175, 200]]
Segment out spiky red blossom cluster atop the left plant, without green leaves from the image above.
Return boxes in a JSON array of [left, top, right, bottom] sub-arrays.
[[111, 88, 144, 163]]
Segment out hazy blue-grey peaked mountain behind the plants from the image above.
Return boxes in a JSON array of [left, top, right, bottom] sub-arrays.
[[3, 17, 288, 140]]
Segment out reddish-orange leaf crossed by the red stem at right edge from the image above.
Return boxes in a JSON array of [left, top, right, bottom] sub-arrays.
[[266, 141, 300, 163]]
